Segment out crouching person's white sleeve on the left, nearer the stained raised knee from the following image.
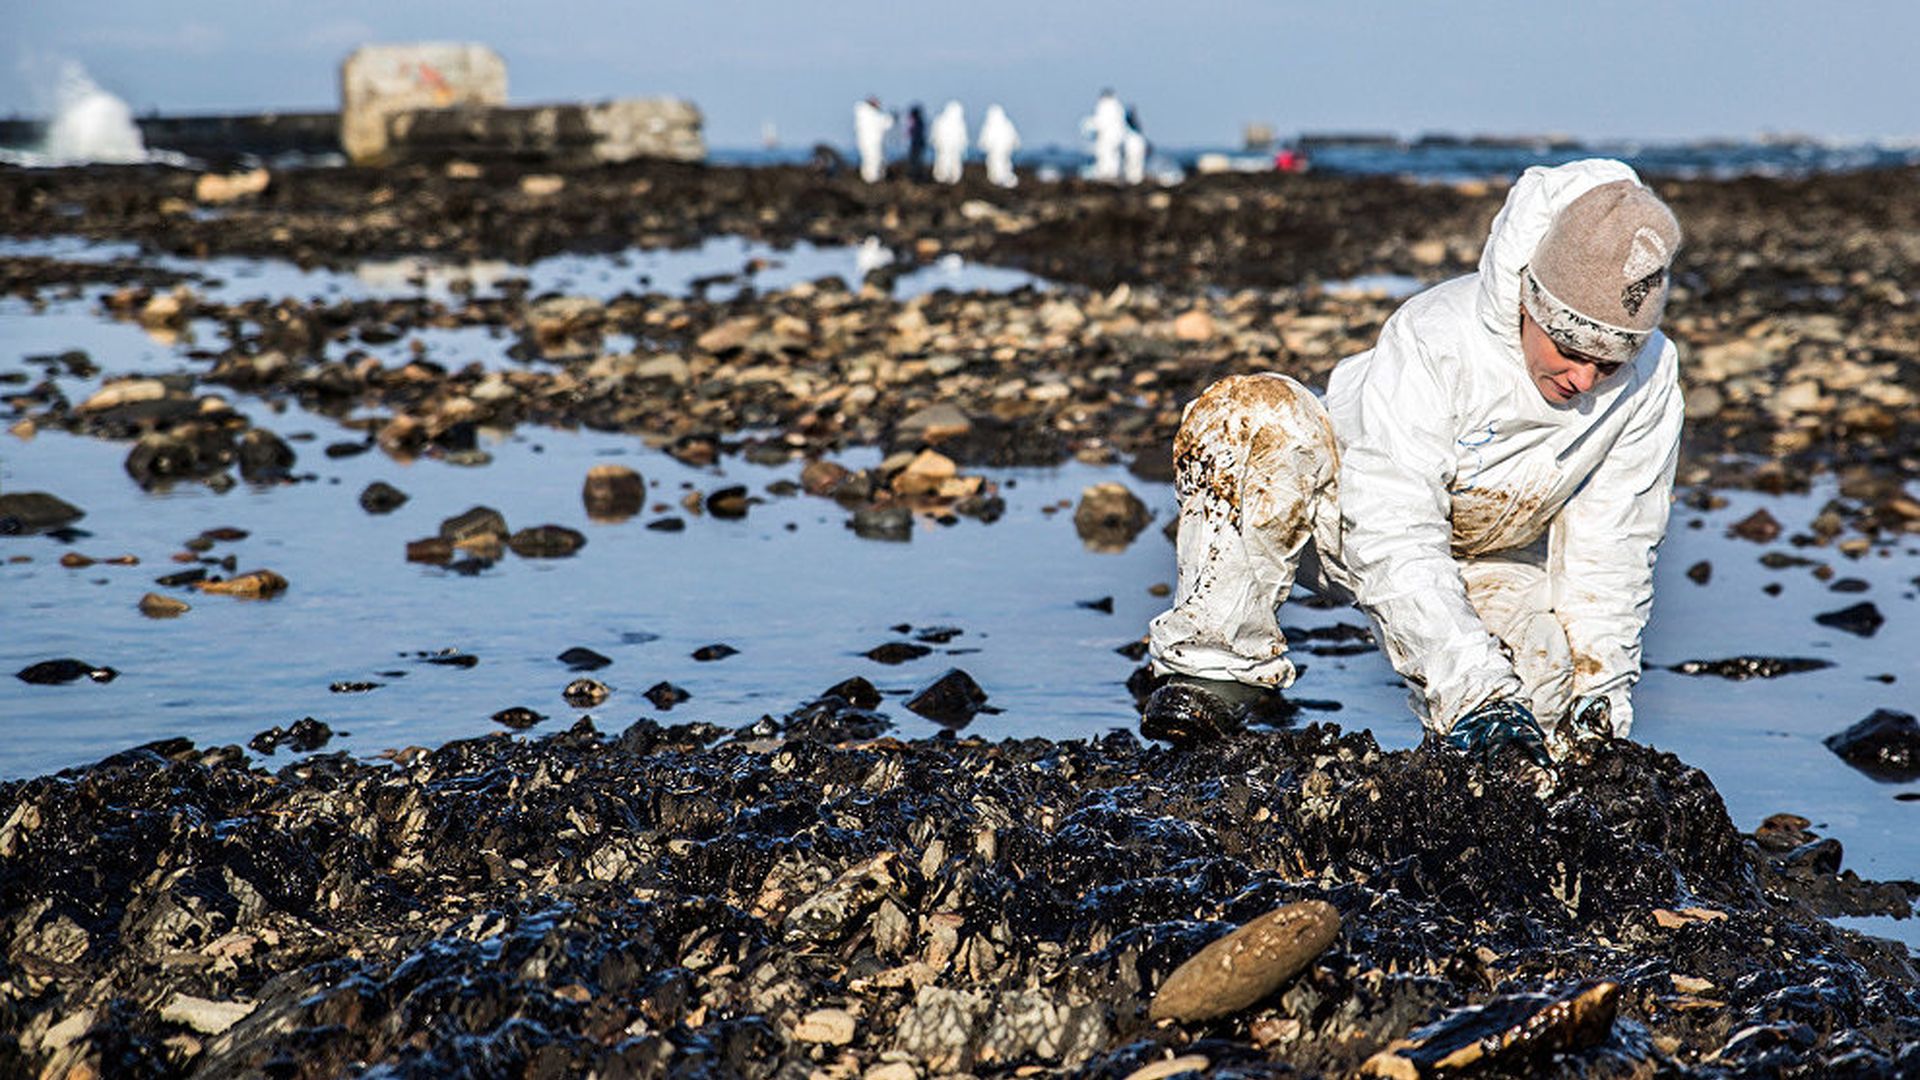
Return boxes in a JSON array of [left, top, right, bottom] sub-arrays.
[[1340, 315, 1521, 732]]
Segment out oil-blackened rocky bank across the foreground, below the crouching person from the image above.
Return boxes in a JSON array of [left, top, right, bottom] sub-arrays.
[[0, 686, 1920, 1078]]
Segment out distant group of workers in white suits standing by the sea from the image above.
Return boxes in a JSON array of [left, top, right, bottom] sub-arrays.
[[852, 90, 1150, 188]]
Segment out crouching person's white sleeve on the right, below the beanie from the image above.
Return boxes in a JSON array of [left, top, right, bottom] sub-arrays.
[[1551, 342, 1684, 736]]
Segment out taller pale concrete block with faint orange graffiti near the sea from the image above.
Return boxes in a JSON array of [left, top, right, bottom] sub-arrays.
[[340, 42, 507, 163]]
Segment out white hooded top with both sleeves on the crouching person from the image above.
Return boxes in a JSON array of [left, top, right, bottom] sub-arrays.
[[1327, 160, 1682, 736]]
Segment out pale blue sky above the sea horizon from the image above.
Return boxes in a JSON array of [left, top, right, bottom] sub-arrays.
[[0, 0, 1920, 148]]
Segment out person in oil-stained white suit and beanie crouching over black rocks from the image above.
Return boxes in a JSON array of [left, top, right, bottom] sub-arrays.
[[1140, 160, 1682, 765]]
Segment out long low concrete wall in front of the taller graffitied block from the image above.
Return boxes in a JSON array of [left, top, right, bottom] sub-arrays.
[[384, 98, 707, 163]]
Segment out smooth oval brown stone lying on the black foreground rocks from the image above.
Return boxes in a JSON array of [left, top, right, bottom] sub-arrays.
[[1146, 899, 1340, 1020]]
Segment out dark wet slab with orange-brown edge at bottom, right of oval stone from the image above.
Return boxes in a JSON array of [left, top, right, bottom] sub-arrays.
[[1361, 980, 1620, 1080]]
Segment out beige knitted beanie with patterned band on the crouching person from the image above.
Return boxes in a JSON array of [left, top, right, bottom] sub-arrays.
[[1521, 181, 1680, 363]]
